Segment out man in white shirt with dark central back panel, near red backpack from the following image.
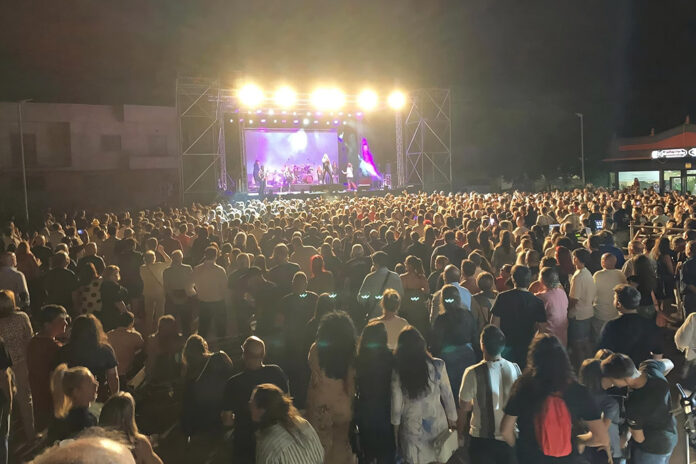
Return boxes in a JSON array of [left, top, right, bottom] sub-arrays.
[[459, 325, 521, 464]]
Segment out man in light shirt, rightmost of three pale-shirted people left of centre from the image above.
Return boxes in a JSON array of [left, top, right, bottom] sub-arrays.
[[193, 246, 227, 339]]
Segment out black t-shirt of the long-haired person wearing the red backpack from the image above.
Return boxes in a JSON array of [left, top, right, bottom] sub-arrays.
[[503, 377, 602, 463]]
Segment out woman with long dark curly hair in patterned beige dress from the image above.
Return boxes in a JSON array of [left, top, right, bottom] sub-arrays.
[[307, 311, 355, 464]]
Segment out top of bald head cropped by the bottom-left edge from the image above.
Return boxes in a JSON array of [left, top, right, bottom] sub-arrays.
[[31, 437, 135, 464]]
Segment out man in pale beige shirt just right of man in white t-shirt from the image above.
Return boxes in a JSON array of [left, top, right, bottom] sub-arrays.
[[592, 253, 626, 343]]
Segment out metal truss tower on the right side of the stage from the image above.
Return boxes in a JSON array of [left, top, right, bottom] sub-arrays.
[[396, 89, 452, 191]]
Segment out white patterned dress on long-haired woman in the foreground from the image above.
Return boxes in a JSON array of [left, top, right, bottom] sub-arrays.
[[391, 358, 457, 464]]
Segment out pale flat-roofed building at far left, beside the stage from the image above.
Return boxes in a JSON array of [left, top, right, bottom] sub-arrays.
[[0, 102, 179, 209]]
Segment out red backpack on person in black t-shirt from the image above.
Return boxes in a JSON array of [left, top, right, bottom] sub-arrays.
[[534, 392, 573, 458]]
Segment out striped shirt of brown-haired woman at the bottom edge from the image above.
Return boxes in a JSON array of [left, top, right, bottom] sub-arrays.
[[256, 418, 324, 464]]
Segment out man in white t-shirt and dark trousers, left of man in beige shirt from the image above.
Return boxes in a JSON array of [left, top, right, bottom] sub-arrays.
[[568, 248, 596, 366]]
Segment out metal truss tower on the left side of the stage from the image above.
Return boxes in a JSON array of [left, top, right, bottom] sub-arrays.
[[176, 77, 227, 205]]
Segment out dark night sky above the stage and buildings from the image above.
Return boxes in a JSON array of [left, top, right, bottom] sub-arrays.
[[0, 0, 696, 180]]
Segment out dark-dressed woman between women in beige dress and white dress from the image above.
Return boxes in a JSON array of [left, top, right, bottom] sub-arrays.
[[354, 321, 395, 464]]
